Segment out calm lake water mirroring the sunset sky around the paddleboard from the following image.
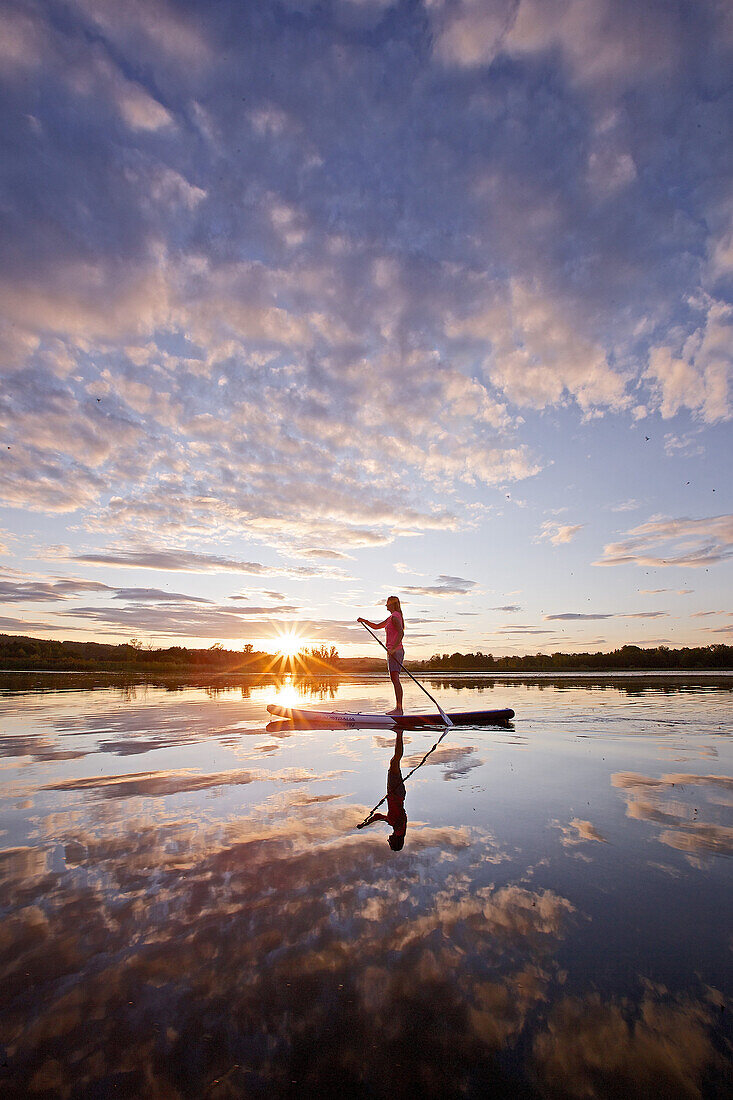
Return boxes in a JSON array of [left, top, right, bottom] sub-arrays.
[[0, 674, 733, 1100]]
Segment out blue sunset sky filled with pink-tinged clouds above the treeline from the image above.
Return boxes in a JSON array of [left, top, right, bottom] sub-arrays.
[[0, 0, 733, 658]]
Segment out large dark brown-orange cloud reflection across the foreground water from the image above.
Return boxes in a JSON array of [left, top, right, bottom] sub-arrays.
[[0, 791, 718, 1097]]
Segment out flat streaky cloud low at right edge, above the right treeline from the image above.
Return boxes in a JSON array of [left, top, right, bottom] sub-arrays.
[[593, 515, 733, 569]]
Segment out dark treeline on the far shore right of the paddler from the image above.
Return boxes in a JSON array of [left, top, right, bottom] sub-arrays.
[[409, 645, 733, 672]]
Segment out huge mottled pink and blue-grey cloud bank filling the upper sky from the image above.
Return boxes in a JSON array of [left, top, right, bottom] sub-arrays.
[[0, 0, 733, 642]]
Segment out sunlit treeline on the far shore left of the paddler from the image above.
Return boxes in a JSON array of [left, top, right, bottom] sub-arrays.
[[0, 634, 339, 673]]
